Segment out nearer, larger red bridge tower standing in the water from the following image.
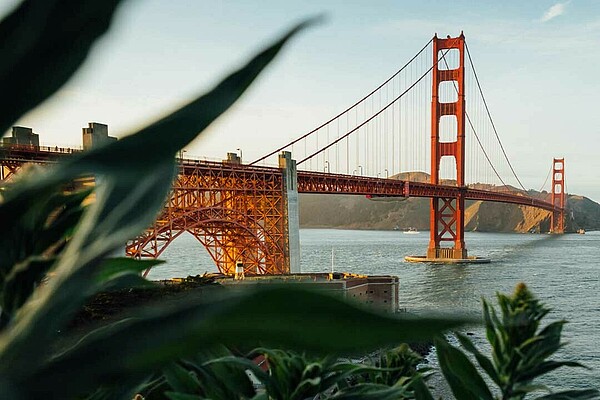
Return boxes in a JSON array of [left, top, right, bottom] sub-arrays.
[[427, 33, 467, 259]]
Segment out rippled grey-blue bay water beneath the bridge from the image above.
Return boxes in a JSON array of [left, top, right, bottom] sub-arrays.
[[149, 229, 600, 398]]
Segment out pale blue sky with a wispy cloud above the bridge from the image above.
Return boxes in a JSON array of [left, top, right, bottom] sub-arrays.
[[0, 0, 600, 202]]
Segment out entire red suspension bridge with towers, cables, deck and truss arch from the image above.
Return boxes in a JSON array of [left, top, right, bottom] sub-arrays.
[[0, 33, 565, 274]]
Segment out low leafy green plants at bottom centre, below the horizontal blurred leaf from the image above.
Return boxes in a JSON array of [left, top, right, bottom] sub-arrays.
[[146, 348, 431, 400]]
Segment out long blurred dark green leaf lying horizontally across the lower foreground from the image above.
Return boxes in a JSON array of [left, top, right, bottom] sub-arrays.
[[22, 284, 472, 394]]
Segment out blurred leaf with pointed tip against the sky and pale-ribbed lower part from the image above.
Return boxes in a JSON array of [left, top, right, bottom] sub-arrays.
[[0, 18, 318, 386]]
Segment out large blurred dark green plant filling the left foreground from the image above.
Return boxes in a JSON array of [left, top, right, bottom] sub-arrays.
[[0, 0, 467, 399]]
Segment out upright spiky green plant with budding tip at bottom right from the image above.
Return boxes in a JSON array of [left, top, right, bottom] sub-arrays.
[[435, 283, 600, 400]]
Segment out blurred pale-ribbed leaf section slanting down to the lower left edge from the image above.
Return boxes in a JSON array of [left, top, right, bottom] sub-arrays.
[[0, 162, 174, 376]]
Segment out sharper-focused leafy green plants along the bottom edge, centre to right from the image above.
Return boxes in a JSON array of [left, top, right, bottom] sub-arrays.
[[140, 284, 599, 400]]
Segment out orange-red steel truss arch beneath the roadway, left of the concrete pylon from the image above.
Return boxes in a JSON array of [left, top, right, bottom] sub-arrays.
[[126, 160, 289, 274]]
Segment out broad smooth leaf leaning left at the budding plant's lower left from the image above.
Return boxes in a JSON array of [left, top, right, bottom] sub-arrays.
[[434, 338, 493, 400]]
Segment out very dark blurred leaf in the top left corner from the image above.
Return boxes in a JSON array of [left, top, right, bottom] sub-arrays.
[[0, 0, 121, 136]]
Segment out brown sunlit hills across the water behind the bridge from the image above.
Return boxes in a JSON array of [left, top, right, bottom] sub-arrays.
[[300, 188, 600, 232]]
